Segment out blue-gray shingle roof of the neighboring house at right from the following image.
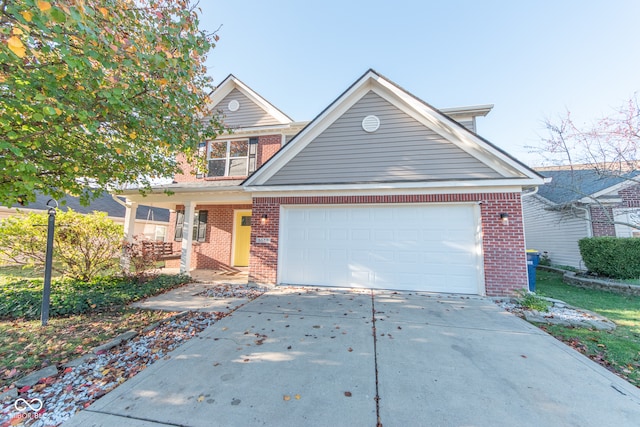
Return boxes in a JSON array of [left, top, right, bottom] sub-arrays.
[[538, 169, 640, 205]]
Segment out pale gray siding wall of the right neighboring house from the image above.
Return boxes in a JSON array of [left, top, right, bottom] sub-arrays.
[[522, 196, 589, 269]]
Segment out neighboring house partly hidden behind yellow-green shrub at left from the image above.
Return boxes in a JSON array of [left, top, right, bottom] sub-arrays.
[[0, 194, 169, 241]]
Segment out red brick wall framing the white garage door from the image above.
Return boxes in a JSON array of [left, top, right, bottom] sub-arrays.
[[249, 193, 527, 295]]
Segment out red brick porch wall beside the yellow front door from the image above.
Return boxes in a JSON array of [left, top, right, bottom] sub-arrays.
[[167, 205, 251, 270]]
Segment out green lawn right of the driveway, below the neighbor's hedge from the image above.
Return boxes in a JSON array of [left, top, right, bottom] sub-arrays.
[[536, 270, 640, 387]]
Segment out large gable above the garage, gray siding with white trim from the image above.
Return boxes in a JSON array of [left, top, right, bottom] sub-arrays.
[[244, 70, 543, 189]]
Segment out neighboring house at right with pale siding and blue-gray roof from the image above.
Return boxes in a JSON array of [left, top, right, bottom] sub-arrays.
[[523, 168, 640, 269]]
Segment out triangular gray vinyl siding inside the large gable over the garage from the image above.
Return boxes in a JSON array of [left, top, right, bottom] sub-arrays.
[[266, 92, 501, 185]]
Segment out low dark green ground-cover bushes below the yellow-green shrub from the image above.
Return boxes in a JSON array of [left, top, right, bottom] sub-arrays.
[[0, 275, 189, 319]]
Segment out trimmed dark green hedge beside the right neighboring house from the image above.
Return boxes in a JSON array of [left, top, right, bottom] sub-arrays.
[[578, 237, 640, 279]]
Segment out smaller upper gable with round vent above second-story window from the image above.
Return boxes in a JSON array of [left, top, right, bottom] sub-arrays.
[[209, 74, 293, 128]]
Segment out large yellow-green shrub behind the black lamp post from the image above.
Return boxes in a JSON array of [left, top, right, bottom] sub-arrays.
[[0, 210, 123, 281]]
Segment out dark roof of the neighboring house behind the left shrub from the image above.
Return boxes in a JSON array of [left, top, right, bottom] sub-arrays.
[[13, 193, 169, 222]]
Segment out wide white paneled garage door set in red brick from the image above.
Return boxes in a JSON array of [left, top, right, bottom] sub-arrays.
[[278, 204, 484, 294]]
